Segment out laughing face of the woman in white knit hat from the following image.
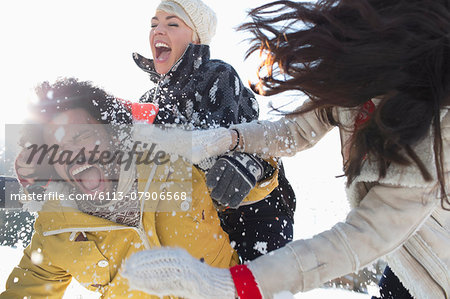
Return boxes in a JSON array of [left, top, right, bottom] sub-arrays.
[[150, 10, 193, 75]]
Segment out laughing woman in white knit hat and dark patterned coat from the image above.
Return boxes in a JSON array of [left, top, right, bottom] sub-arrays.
[[133, 0, 295, 261]]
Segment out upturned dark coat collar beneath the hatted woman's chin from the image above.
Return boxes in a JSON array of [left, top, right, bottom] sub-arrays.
[[133, 44, 210, 82]]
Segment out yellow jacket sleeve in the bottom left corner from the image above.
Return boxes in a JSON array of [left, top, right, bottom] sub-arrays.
[[0, 232, 72, 299]]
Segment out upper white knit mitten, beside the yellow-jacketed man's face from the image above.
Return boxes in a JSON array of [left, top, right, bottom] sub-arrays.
[[133, 125, 232, 164]]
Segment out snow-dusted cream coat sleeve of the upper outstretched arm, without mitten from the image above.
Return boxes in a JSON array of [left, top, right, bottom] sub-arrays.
[[231, 110, 333, 157]]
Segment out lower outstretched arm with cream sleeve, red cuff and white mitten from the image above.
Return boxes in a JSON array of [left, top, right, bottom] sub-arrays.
[[121, 186, 439, 299]]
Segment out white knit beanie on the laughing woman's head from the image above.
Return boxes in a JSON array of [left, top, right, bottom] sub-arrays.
[[156, 0, 217, 45]]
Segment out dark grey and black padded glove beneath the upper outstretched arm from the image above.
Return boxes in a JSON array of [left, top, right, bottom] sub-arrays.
[[206, 152, 264, 208]]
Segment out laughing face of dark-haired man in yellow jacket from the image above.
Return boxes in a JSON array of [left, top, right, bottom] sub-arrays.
[[44, 108, 117, 194]]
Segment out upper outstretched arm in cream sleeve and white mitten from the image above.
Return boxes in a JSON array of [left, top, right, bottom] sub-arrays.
[[134, 106, 333, 164]]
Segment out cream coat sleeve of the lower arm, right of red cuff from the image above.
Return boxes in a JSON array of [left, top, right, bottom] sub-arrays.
[[249, 185, 439, 298]]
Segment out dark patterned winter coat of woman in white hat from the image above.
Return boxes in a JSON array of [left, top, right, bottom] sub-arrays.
[[133, 44, 295, 260]]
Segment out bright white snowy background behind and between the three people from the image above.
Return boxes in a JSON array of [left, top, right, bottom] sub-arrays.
[[0, 0, 377, 299]]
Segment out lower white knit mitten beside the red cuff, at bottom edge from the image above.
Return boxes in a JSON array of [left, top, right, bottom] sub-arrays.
[[122, 248, 235, 299]]
